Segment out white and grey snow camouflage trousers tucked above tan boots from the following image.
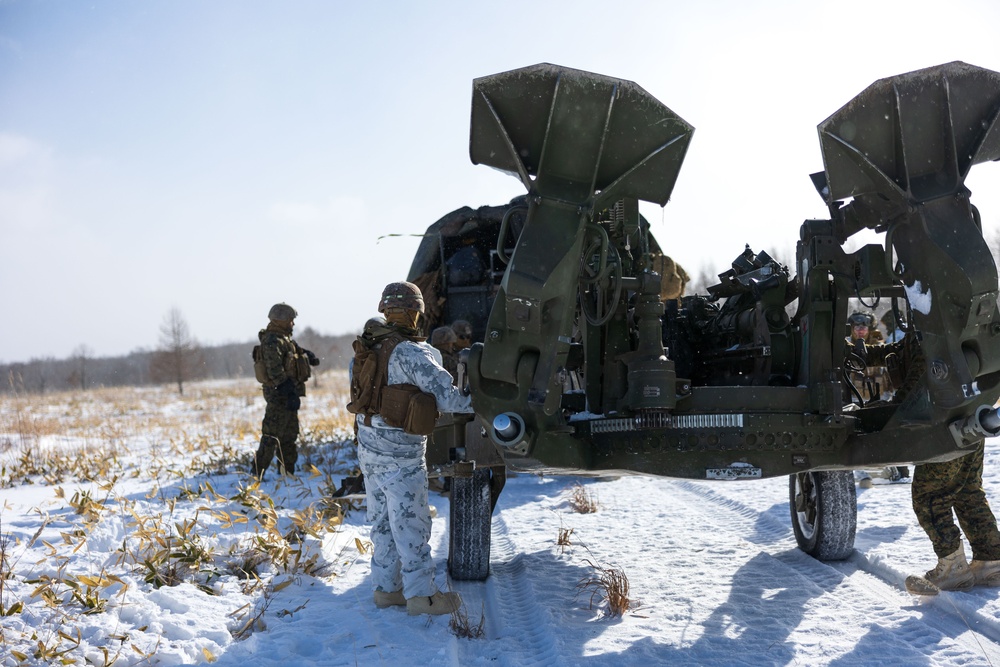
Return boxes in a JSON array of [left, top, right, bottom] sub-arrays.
[[358, 425, 438, 598]]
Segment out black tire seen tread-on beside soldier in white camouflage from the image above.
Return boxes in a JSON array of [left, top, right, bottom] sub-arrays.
[[448, 468, 493, 581]]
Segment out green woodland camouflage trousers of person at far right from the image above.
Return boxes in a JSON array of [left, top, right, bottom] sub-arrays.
[[912, 443, 1000, 560]]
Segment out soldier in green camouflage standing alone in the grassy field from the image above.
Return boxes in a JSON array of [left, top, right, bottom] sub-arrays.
[[252, 303, 319, 479]]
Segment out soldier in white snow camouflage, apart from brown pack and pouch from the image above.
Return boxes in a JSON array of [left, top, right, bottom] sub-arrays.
[[352, 282, 472, 615]]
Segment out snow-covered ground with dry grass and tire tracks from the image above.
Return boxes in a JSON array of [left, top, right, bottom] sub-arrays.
[[0, 376, 1000, 667]]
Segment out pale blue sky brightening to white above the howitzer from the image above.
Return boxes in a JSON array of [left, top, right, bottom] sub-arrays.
[[0, 0, 1000, 361]]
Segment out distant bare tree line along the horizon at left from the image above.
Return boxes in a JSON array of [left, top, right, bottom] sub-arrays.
[[0, 324, 356, 393]]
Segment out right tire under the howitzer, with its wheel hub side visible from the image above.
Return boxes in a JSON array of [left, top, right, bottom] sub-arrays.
[[788, 470, 858, 560]]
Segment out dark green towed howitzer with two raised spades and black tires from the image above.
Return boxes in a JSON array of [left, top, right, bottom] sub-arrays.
[[410, 62, 1000, 579]]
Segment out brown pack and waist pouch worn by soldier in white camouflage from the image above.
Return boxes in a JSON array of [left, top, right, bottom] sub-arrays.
[[347, 333, 438, 435]]
